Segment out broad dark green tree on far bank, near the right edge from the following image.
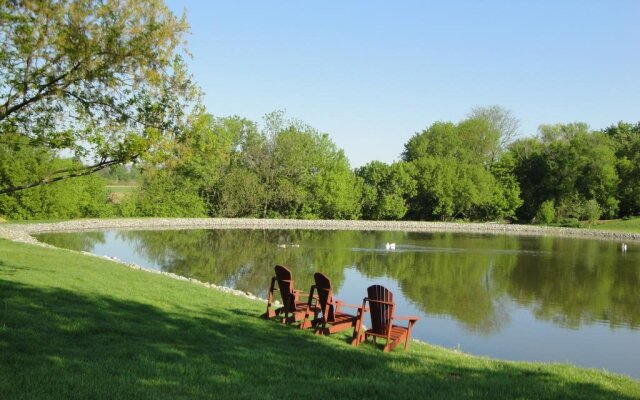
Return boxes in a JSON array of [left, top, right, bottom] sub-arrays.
[[510, 123, 619, 219]]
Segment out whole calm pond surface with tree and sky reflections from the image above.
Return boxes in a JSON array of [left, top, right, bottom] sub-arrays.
[[39, 230, 640, 378]]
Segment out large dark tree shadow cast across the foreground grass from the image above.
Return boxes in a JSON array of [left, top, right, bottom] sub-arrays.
[[0, 280, 631, 399]]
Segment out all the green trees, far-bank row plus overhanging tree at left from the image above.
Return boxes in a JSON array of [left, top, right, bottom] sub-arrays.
[[0, 0, 640, 225]]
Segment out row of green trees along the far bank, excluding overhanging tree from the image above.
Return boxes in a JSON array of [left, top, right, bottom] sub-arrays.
[[0, 106, 640, 226]]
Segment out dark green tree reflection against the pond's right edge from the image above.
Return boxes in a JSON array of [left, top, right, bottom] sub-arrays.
[[508, 238, 640, 329]]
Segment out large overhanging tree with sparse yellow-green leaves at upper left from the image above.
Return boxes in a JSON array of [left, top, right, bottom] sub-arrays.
[[0, 0, 197, 193]]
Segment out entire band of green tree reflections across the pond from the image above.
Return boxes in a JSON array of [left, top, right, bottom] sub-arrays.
[[47, 230, 640, 334]]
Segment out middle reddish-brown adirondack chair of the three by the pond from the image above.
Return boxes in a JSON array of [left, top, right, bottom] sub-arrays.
[[307, 272, 363, 346]]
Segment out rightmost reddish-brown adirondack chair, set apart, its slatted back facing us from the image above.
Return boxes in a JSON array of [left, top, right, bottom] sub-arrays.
[[362, 285, 420, 352]]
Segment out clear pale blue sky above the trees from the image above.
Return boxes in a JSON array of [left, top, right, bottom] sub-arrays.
[[167, 0, 640, 167]]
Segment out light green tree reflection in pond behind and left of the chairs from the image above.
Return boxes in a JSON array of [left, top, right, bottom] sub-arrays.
[[114, 230, 358, 296]]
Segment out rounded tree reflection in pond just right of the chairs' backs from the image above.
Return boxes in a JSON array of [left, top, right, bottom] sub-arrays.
[[358, 233, 517, 334]]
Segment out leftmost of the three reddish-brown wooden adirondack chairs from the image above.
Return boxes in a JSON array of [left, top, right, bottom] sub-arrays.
[[261, 265, 317, 329]]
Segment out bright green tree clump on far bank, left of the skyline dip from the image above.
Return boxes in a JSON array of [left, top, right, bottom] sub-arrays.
[[134, 111, 360, 219]]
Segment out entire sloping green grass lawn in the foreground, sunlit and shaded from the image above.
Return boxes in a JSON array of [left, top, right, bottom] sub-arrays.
[[0, 240, 640, 400]]
